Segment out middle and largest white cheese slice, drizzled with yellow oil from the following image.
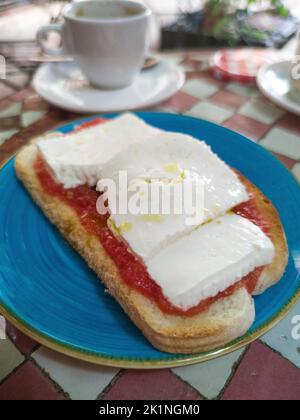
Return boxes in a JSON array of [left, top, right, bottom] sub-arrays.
[[99, 133, 249, 260]]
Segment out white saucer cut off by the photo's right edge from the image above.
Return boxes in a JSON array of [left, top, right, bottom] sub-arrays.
[[257, 61, 300, 115]]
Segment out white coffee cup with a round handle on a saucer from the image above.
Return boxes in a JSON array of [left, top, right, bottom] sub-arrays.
[[37, 0, 151, 89]]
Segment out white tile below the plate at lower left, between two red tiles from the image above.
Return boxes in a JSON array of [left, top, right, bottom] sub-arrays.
[[32, 347, 118, 400]]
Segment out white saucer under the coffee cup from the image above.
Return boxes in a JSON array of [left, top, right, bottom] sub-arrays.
[[33, 61, 185, 113]]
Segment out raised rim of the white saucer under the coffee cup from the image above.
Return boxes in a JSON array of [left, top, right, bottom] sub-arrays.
[[32, 60, 186, 114]]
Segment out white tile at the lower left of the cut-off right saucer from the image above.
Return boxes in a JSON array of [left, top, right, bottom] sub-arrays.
[[239, 99, 285, 125]]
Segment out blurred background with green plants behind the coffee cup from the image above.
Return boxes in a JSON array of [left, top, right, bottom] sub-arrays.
[[0, 0, 300, 91]]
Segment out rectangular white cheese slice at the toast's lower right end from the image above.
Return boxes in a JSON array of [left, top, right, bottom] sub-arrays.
[[146, 214, 274, 310]]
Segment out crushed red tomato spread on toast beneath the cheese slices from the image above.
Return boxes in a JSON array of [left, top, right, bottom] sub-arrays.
[[34, 118, 268, 316]]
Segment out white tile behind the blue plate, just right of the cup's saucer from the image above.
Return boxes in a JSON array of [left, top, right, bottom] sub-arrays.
[[186, 102, 234, 124]]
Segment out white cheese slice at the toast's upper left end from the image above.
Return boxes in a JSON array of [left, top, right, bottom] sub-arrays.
[[38, 114, 160, 188]]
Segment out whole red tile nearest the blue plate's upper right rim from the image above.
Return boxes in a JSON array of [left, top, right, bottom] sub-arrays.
[[223, 114, 271, 140]]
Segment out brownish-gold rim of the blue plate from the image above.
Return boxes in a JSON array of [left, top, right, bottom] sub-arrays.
[[0, 112, 300, 369]]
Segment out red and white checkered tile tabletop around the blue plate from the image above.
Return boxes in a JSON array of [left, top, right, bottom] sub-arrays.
[[0, 52, 300, 400]]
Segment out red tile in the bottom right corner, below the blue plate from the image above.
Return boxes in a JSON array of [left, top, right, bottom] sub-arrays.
[[223, 342, 300, 401]]
